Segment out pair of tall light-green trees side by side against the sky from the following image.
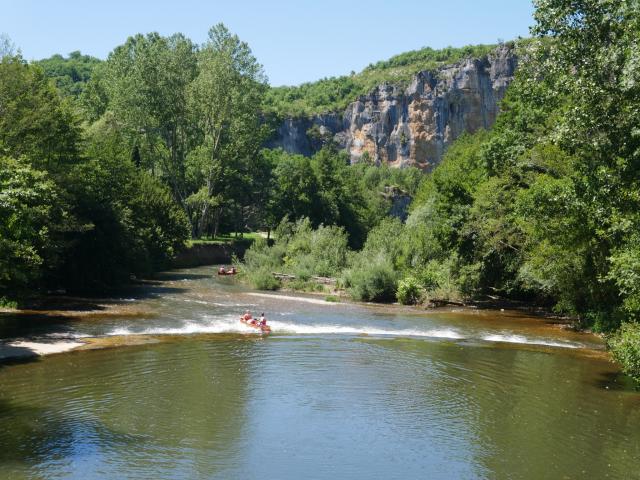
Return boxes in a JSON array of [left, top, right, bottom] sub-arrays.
[[80, 24, 268, 236]]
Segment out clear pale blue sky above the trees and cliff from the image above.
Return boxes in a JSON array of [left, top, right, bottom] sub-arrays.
[[0, 0, 533, 85]]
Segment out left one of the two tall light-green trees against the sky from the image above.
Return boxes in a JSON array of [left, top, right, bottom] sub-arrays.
[[100, 33, 197, 206]]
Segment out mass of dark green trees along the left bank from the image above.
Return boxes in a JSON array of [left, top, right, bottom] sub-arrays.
[[0, 49, 188, 297]]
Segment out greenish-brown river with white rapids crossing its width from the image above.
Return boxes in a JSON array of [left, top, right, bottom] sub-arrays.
[[0, 267, 640, 480]]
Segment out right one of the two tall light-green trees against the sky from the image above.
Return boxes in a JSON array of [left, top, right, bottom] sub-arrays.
[[189, 24, 267, 237]]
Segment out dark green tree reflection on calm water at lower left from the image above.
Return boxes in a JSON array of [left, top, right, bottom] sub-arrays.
[[0, 341, 252, 478]]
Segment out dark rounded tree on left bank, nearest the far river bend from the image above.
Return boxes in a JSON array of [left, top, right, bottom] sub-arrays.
[[61, 120, 189, 289]]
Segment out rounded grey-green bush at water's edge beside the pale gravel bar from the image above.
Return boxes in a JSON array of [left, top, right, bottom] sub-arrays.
[[344, 261, 396, 302]]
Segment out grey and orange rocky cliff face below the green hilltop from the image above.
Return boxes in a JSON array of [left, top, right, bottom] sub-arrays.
[[270, 46, 517, 170]]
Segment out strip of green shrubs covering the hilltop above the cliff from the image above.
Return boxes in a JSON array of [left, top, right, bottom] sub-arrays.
[[265, 45, 495, 116]]
